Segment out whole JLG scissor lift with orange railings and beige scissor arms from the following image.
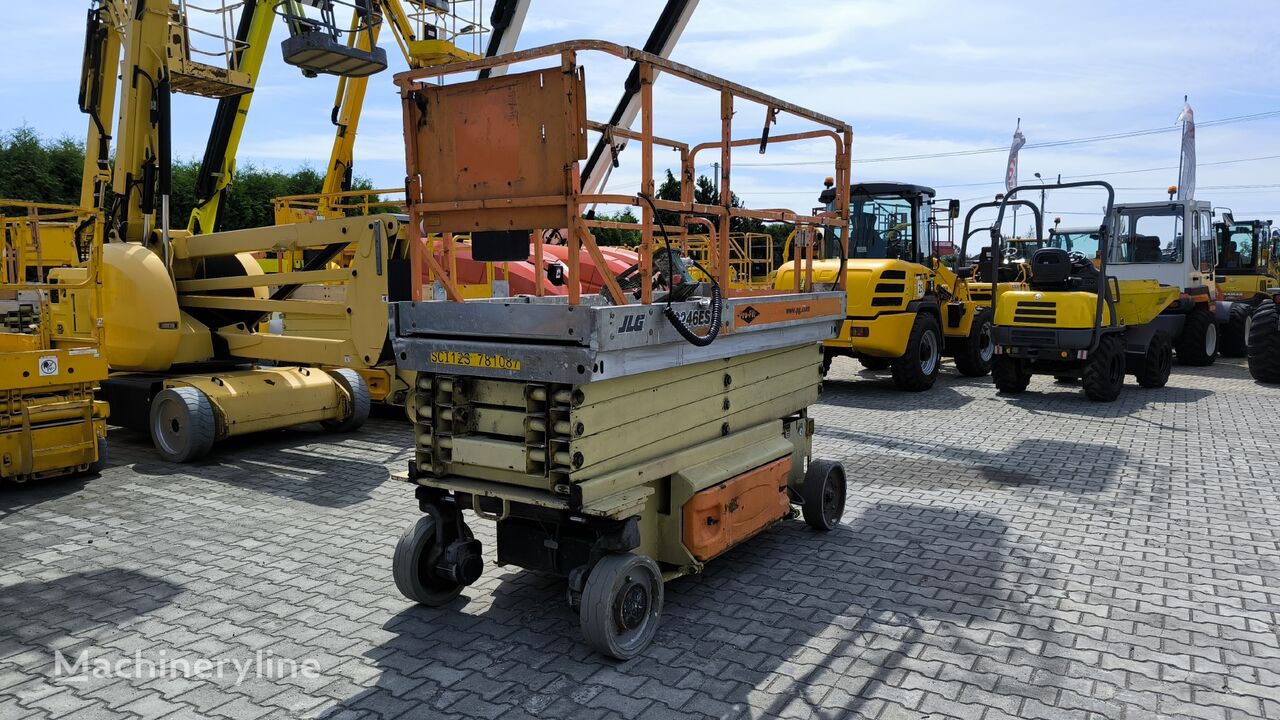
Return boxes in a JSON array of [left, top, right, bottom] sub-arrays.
[[390, 41, 852, 659]]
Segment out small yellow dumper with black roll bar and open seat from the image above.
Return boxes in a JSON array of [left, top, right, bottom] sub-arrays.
[[989, 181, 1180, 402]]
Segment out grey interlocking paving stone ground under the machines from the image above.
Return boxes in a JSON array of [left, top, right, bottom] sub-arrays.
[[0, 360, 1280, 720]]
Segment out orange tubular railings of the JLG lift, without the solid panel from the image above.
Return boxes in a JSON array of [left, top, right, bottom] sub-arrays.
[[396, 40, 852, 305]]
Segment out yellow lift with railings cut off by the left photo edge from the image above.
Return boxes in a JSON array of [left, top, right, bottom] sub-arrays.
[[0, 201, 108, 482]]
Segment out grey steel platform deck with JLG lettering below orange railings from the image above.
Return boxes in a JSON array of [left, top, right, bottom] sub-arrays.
[[389, 292, 845, 384]]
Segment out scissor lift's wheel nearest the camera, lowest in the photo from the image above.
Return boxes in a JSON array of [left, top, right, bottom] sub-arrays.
[[579, 552, 663, 660]]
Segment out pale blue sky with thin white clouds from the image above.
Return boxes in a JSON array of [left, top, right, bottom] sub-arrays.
[[0, 0, 1280, 224]]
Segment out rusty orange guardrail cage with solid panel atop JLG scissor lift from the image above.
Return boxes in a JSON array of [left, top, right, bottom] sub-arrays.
[[396, 40, 852, 305]]
